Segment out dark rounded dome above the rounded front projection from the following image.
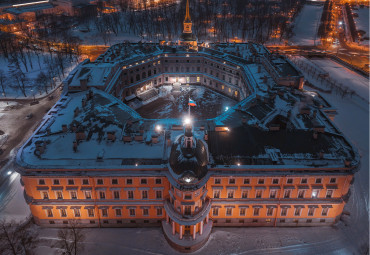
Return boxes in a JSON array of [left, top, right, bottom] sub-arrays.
[[169, 135, 208, 182]]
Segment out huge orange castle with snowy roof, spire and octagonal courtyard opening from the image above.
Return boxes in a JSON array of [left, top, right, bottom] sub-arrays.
[[16, 1, 359, 252]]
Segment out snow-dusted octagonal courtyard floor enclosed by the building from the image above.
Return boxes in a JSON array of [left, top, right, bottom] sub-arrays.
[[136, 85, 236, 119]]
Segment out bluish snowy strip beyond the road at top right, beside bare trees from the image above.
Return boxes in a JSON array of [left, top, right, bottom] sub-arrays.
[[289, 4, 323, 45]]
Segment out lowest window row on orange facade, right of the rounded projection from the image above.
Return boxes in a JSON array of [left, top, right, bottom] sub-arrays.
[[212, 205, 332, 217]]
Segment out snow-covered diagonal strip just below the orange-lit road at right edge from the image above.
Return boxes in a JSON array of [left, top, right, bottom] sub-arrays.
[[311, 59, 369, 101]]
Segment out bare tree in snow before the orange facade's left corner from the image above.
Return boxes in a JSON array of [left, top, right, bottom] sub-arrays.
[[53, 220, 85, 255]]
